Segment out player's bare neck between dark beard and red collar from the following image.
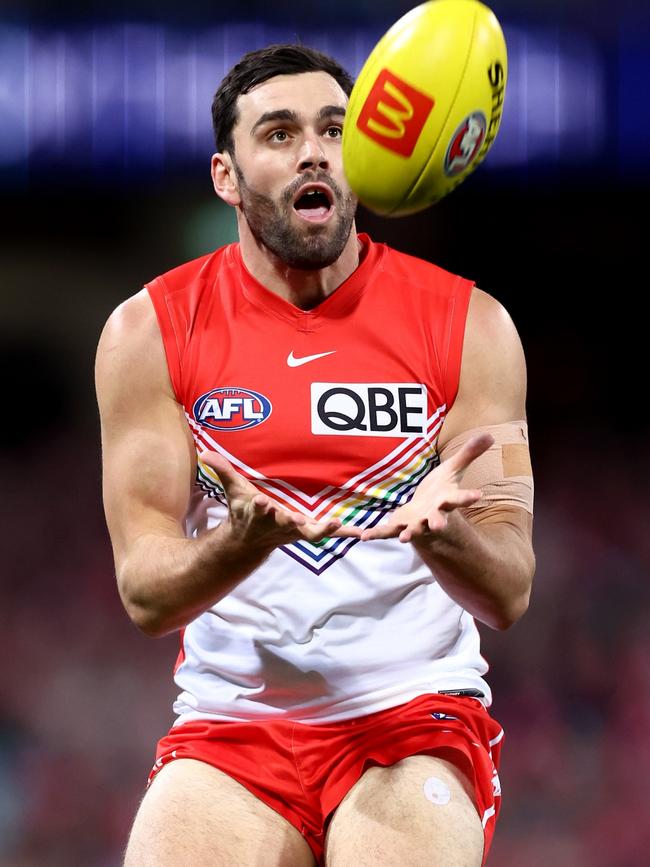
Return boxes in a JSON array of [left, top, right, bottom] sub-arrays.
[[239, 220, 360, 310]]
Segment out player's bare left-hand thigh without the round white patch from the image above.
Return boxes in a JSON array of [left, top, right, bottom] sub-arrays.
[[124, 759, 315, 867]]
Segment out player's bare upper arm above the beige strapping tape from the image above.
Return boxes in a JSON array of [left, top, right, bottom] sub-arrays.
[[438, 289, 526, 451]]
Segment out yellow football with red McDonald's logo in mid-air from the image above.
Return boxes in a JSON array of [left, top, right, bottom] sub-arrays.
[[343, 0, 508, 217]]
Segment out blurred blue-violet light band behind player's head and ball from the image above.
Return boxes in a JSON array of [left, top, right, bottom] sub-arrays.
[[0, 23, 608, 174]]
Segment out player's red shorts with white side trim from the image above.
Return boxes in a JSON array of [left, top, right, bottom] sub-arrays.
[[149, 694, 503, 865]]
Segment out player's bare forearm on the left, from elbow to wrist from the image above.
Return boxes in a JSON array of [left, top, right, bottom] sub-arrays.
[[117, 521, 272, 637]]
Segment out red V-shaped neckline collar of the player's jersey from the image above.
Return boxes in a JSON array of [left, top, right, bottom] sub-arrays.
[[229, 232, 385, 331]]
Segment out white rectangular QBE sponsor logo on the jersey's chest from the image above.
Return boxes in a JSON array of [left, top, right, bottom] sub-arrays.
[[311, 382, 427, 437]]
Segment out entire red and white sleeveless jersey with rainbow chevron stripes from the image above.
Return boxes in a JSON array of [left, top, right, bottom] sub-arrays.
[[147, 235, 488, 721]]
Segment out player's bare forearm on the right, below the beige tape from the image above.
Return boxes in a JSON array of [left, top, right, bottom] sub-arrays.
[[414, 511, 535, 629]]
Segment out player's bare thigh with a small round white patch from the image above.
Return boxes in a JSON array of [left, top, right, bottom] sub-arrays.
[[325, 756, 483, 867]]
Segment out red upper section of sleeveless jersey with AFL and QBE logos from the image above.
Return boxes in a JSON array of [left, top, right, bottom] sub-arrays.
[[147, 235, 472, 536]]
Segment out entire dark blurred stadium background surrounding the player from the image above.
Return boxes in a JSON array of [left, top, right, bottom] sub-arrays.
[[0, 0, 650, 867]]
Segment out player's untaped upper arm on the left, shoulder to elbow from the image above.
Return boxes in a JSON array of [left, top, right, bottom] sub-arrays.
[[95, 290, 196, 573]]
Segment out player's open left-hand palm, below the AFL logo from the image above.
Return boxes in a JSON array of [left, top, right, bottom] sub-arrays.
[[200, 451, 361, 550]]
